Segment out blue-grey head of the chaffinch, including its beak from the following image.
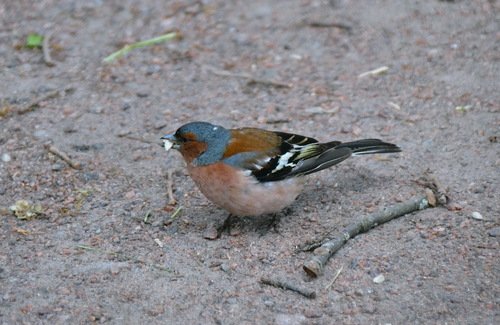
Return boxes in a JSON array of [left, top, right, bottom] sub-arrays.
[[162, 122, 231, 166]]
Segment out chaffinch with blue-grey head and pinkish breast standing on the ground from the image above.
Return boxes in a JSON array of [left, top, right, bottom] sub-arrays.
[[161, 122, 401, 216]]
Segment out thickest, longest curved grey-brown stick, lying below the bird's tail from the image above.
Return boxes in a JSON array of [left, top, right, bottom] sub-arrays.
[[303, 196, 429, 277]]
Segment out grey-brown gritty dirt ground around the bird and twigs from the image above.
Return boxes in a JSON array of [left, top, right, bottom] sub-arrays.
[[0, 0, 500, 324]]
